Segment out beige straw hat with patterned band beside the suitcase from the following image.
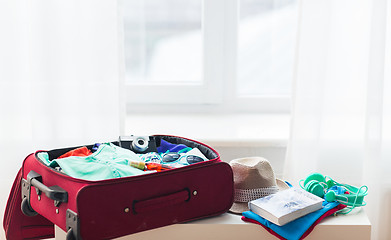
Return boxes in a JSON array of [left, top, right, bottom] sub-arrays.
[[229, 157, 289, 213]]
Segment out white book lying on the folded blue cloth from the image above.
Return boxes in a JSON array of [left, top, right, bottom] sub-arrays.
[[248, 187, 324, 226]]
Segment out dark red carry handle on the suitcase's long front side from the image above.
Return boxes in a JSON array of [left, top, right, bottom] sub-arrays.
[[133, 188, 190, 214]]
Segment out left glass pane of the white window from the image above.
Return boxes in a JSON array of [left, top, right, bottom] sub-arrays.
[[124, 0, 202, 85]]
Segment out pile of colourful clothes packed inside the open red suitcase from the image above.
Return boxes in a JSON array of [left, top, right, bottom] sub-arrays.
[[37, 139, 208, 181]]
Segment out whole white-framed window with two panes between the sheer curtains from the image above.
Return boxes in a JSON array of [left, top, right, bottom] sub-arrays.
[[121, 0, 297, 112]]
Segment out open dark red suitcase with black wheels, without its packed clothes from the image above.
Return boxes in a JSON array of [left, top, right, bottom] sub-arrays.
[[3, 135, 234, 240]]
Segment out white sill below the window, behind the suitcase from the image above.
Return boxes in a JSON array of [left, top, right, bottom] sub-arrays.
[[125, 114, 290, 147]]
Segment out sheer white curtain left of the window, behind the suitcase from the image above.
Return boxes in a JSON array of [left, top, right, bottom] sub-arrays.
[[0, 0, 122, 238]]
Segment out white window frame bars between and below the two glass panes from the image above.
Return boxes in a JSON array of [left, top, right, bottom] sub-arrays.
[[121, 0, 290, 113]]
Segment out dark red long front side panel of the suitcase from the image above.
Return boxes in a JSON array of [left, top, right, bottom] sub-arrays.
[[78, 162, 233, 240]]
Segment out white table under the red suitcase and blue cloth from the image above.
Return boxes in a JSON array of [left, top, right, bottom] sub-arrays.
[[55, 209, 371, 240]]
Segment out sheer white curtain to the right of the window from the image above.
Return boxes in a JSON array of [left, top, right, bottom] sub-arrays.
[[285, 0, 391, 239]]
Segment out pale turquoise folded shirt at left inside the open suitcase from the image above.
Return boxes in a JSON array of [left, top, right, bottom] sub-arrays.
[[38, 143, 148, 181]]
